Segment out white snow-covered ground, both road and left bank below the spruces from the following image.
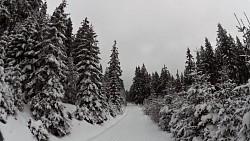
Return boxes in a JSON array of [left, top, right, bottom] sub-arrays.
[[0, 104, 174, 141]]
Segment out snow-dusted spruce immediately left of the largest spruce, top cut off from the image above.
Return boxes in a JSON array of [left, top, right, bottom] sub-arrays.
[[1, 0, 42, 110]]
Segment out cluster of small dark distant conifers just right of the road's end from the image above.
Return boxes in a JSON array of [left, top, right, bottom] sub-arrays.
[[127, 64, 177, 104]]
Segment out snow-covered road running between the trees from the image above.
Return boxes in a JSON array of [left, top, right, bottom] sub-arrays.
[[87, 105, 174, 141]]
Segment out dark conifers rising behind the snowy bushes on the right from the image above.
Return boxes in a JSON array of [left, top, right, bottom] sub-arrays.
[[130, 24, 250, 104]]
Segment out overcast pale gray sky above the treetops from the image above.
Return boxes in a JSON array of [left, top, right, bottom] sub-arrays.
[[47, 0, 250, 89]]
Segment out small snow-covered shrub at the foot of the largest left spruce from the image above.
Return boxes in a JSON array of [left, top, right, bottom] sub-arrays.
[[28, 119, 48, 141]]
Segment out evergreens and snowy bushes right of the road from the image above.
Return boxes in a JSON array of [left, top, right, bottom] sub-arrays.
[[127, 24, 250, 141]]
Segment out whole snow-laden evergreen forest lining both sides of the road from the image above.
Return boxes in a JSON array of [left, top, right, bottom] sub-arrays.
[[0, 0, 250, 141]]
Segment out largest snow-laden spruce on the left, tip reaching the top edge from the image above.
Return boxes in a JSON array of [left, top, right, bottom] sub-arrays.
[[27, 1, 70, 137]]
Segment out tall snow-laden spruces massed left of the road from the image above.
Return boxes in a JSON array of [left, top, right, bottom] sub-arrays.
[[0, 0, 125, 140]]
